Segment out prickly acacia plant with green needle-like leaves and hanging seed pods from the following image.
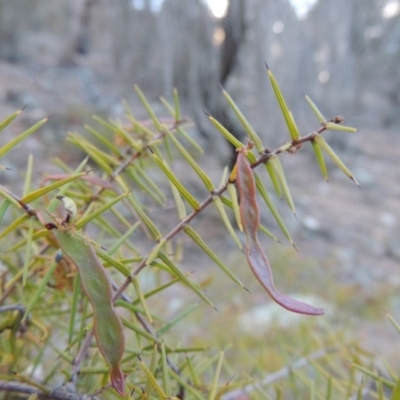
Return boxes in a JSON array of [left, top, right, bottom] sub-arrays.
[[0, 69, 394, 400]]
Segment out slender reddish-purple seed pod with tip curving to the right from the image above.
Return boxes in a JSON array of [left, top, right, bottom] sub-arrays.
[[236, 148, 324, 315]]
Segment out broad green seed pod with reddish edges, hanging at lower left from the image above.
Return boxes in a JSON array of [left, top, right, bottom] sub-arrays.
[[41, 205, 125, 395]]
